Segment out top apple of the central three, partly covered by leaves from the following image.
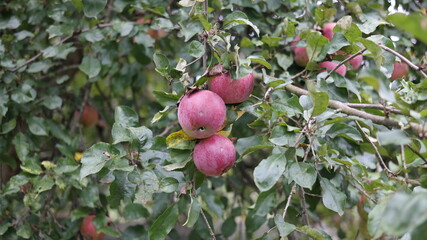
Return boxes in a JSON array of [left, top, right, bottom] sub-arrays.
[[209, 73, 254, 104]]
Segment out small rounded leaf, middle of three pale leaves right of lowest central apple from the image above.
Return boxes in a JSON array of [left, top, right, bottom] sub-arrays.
[[288, 162, 317, 189]]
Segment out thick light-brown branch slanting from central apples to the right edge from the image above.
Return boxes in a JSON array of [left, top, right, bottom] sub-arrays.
[[254, 73, 427, 138]]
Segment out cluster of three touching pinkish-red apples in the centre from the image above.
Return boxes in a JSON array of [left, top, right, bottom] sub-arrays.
[[178, 72, 254, 176]]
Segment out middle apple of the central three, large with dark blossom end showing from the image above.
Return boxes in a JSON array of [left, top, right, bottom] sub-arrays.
[[178, 90, 226, 138]]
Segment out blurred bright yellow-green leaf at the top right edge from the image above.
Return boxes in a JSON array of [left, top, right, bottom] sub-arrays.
[[387, 13, 427, 43]]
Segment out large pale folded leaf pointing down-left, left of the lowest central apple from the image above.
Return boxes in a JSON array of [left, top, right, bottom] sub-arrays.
[[80, 142, 118, 179]]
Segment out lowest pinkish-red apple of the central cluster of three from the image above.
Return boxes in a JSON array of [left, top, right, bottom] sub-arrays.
[[193, 134, 236, 176]]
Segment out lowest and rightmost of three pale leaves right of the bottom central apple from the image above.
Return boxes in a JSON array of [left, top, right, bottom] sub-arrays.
[[320, 178, 347, 216]]
